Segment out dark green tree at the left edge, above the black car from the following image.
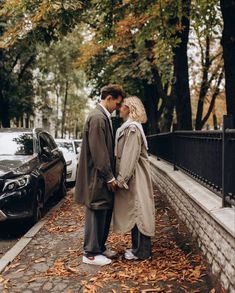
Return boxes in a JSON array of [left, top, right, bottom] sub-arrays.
[[0, 23, 36, 127]]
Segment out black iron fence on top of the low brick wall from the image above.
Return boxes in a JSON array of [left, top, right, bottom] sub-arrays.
[[148, 118, 235, 206]]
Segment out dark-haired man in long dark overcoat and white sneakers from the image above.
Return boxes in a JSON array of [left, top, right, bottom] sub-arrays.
[[75, 84, 125, 266]]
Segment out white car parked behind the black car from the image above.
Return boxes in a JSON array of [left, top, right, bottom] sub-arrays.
[[55, 139, 79, 183]]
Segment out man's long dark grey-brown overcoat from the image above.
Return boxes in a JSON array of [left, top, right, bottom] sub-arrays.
[[75, 105, 115, 210]]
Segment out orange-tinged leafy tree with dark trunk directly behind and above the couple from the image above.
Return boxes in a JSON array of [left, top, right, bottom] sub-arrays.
[[75, 0, 195, 133]]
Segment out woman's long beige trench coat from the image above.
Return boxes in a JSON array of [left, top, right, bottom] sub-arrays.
[[113, 125, 155, 236]]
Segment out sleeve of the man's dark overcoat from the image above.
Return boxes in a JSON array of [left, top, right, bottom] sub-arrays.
[[88, 117, 114, 182]]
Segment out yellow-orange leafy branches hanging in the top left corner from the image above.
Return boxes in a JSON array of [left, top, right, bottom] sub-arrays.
[[0, 0, 85, 47]]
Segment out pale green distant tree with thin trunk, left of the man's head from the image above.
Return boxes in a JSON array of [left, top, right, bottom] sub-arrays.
[[36, 31, 87, 138]]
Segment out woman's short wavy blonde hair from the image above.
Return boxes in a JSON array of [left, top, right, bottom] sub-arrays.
[[123, 96, 147, 123]]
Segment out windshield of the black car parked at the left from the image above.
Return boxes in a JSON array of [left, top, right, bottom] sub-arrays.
[[0, 132, 33, 156]]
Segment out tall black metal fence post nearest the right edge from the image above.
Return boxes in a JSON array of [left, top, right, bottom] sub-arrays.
[[222, 115, 233, 207]]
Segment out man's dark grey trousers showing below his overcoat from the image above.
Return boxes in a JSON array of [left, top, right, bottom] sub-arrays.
[[83, 208, 113, 257]]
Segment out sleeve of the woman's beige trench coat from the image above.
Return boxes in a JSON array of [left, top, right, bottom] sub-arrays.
[[117, 126, 141, 189]]
